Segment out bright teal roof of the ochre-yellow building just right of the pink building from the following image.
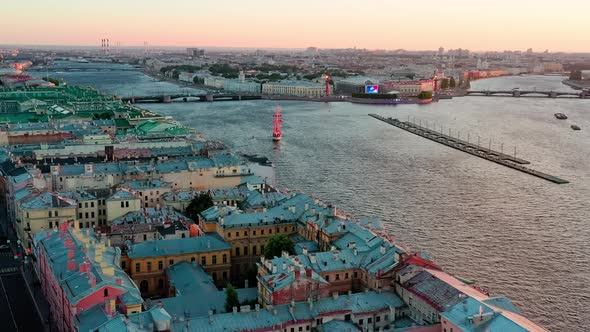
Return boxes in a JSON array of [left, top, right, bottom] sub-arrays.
[[127, 235, 231, 258]]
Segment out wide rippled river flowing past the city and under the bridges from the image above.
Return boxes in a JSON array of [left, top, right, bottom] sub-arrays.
[[37, 63, 590, 331]]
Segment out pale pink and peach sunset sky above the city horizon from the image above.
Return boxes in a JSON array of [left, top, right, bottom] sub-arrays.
[[0, 0, 590, 52]]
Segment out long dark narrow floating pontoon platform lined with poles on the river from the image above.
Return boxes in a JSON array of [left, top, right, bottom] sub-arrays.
[[369, 114, 569, 184]]
